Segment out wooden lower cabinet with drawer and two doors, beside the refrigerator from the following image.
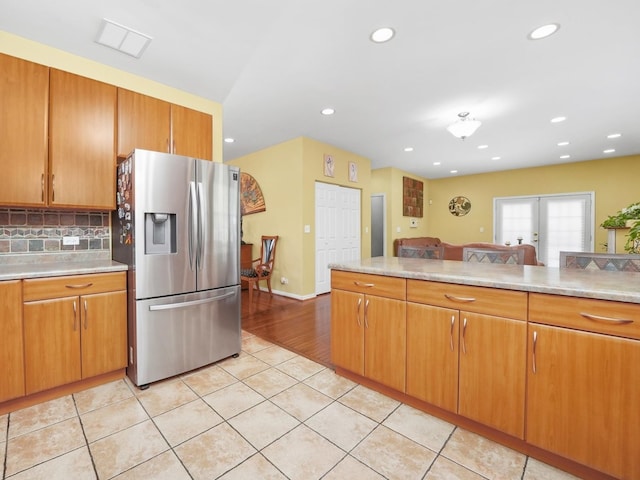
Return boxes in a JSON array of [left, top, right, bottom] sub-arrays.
[[23, 273, 127, 395]]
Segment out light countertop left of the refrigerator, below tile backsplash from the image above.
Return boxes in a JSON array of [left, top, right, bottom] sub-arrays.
[[0, 252, 127, 281]]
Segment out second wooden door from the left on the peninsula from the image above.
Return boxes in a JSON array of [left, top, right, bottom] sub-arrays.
[[363, 295, 407, 392]]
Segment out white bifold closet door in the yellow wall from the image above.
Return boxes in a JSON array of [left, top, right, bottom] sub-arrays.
[[315, 182, 361, 295]]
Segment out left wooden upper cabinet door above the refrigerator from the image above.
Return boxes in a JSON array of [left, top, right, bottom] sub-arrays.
[[118, 88, 171, 157]]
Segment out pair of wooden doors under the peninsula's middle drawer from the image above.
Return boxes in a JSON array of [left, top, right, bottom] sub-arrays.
[[406, 302, 527, 439]]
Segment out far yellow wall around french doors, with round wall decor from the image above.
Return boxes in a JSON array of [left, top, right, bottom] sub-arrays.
[[424, 155, 640, 252]]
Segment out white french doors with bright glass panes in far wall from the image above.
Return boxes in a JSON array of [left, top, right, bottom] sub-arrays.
[[493, 192, 594, 267]]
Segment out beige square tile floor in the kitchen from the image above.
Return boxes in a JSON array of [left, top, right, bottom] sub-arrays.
[[0, 332, 575, 480]]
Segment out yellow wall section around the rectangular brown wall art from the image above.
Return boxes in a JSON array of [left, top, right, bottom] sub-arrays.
[[371, 168, 429, 257]]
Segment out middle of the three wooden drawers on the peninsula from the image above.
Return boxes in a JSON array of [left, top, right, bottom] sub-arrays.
[[407, 280, 527, 320]]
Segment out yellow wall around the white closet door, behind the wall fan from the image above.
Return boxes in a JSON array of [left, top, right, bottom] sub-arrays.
[[227, 137, 371, 298]]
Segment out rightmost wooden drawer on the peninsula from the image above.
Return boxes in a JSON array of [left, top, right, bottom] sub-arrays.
[[529, 293, 640, 339]]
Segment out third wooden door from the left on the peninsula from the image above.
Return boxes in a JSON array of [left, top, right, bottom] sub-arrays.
[[407, 303, 459, 413]]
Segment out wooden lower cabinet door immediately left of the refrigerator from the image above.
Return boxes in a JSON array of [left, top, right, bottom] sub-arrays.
[[80, 291, 127, 378]]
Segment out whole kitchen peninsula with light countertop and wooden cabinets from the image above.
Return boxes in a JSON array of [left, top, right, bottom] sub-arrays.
[[329, 257, 640, 480]]
